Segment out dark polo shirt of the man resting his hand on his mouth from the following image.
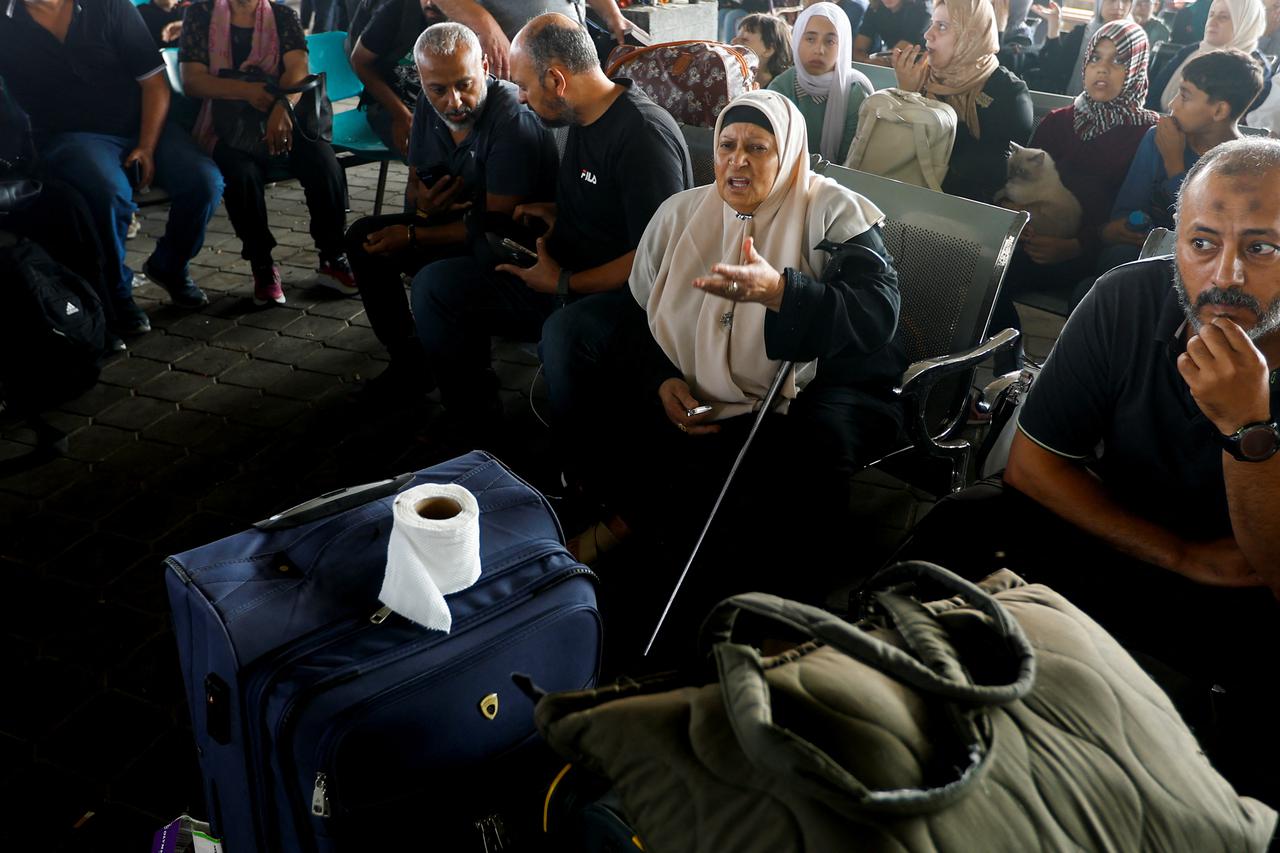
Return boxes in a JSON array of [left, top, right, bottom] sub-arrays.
[[1019, 257, 1280, 539]]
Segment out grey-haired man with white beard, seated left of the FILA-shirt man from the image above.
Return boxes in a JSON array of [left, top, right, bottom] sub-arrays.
[[347, 23, 556, 400]]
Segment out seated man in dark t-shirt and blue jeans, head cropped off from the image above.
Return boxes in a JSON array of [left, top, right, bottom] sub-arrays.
[[0, 0, 223, 333]]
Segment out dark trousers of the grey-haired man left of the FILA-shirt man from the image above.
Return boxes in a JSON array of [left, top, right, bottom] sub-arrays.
[[346, 213, 467, 361]]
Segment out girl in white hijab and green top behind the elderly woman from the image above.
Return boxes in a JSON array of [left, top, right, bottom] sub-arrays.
[[769, 3, 873, 163]]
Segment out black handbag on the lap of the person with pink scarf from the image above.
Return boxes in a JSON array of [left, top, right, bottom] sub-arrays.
[[212, 68, 333, 158]]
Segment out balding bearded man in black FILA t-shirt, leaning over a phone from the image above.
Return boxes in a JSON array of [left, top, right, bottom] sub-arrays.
[[413, 14, 692, 439]]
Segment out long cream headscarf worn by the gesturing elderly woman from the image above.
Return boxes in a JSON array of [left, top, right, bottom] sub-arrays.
[[630, 91, 884, 420]]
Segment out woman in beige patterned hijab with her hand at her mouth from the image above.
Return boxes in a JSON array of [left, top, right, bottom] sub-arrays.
[[893, 0, 1032, 204]]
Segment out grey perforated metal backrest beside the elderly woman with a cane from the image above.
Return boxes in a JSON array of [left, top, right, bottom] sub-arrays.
[[814, 158, 1028, 430]]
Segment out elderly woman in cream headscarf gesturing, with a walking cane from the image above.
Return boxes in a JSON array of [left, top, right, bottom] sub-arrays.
[[560, 91, 906, 604]]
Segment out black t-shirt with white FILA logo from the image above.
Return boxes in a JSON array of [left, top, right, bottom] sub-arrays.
[[548, 78, 694, 270]]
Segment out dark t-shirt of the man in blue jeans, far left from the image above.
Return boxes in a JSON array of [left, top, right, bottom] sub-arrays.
[[0, 0, 164, 138]]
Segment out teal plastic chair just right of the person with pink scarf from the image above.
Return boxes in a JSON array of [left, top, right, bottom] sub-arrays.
[[307, 32, 402, 216]]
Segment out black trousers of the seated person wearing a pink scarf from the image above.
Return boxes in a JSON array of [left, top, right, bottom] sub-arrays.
[[212, 136, 345, 266]]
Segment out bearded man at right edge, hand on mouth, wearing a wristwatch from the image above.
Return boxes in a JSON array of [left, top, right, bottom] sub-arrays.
[[905, 138, 1280, 806]]
